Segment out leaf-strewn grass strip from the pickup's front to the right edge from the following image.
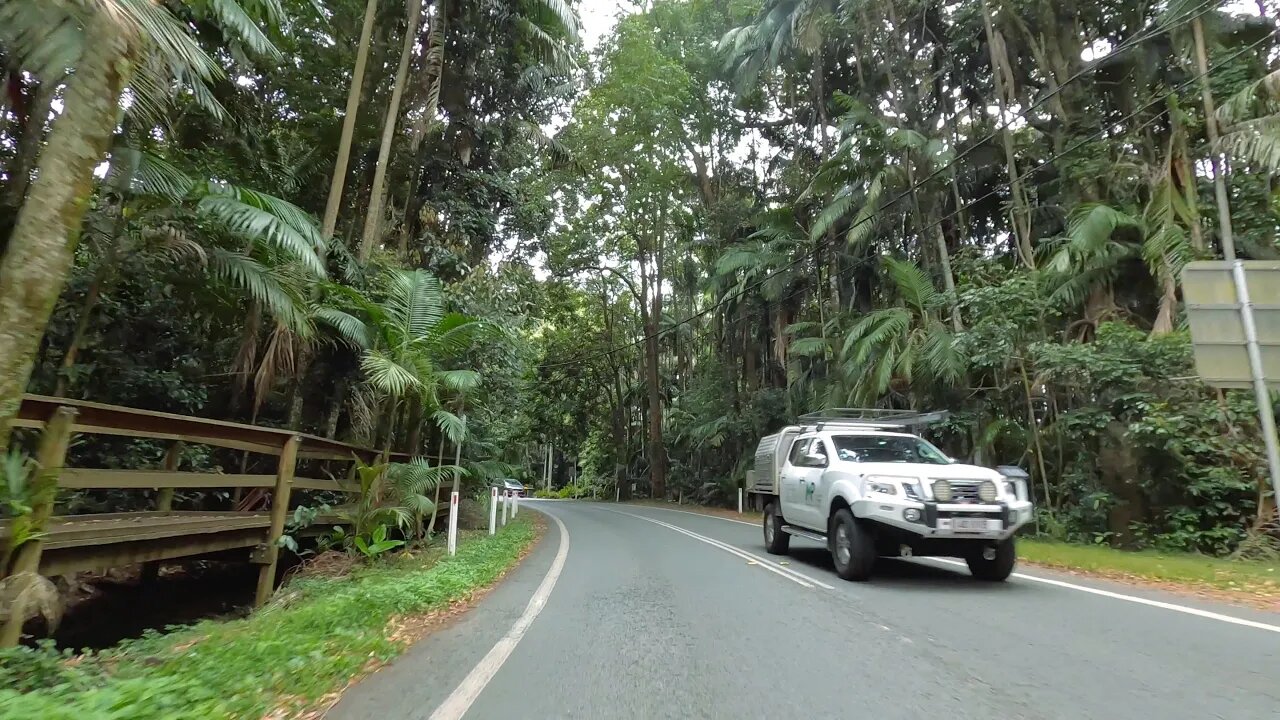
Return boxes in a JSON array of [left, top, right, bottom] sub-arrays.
[[1018, 539, 1280, 594]]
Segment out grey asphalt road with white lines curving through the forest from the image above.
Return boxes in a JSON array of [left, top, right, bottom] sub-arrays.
[[328, 502, 1280, 720]]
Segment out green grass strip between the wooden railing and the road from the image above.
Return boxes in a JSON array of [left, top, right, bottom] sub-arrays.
[[0, 518, 535, 720]]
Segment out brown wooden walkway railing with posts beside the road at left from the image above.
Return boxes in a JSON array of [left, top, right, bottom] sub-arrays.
[[0, 395, 407, 647]]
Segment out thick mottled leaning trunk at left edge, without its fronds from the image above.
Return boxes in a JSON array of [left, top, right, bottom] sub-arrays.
[[0, 18, 138, 451]]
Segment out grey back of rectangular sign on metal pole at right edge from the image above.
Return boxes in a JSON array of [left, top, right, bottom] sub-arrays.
[[1183, 260, 1280, 388]]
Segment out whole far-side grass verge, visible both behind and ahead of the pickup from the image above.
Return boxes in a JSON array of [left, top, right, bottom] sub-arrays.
[[630, 500, 1280, 610]]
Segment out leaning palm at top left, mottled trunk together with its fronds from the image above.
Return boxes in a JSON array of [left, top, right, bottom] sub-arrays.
[[0, 0, 279, 450]]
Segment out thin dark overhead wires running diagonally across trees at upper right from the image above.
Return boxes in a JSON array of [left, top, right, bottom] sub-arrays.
[[538, 0, 1239, 369]]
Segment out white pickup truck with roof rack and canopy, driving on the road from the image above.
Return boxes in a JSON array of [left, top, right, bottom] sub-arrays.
[[748, 409, 1034, 582]]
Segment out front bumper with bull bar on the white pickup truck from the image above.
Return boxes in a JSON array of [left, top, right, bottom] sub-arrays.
[[852, 496, 1033, 541]]
